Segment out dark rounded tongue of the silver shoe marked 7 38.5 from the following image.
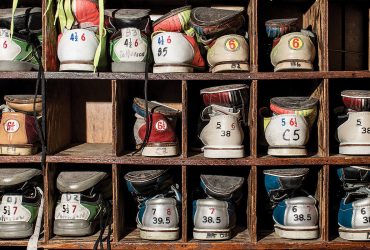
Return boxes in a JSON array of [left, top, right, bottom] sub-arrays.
[[200, 175, 244, 200]]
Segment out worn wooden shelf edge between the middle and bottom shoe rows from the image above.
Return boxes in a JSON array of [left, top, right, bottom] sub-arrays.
[[0, 154, 370, 167]]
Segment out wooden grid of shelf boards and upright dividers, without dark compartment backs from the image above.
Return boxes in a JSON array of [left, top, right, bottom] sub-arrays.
[[0, 0, 370, 249]]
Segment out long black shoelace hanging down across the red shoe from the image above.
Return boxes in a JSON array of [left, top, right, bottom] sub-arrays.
[[131, 32, 152, 156]]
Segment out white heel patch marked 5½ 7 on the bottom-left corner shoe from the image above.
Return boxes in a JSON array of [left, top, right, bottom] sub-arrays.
[[0, 195, 31, 222]]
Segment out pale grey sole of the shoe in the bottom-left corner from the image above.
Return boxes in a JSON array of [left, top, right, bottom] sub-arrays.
[[0, 222, 33, 239]]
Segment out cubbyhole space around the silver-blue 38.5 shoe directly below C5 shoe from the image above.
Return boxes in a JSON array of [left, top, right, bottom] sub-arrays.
[[257, 166, 327, 243]]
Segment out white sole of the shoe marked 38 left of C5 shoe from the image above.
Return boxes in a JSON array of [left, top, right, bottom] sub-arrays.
[[204, 145, 244, 158]]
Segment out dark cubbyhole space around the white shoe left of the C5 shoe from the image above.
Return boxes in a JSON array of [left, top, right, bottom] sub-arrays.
[[187, 81, 252, 158]]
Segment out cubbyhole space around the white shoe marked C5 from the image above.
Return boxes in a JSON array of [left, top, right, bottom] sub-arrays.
[[257, 80, 327, 157]]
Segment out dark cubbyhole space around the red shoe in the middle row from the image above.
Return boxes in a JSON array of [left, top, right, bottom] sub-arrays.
[[115, 81, 183, 155]]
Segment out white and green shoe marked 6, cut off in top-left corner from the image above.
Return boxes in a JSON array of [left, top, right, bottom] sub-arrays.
[[0, 7, 42, 71]]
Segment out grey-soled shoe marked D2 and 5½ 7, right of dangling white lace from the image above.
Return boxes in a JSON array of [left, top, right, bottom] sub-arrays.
[[54, 171, 111, 237]]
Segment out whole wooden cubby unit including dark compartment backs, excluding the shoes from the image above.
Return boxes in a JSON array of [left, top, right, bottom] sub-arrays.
[[0, 0, 370, 249]]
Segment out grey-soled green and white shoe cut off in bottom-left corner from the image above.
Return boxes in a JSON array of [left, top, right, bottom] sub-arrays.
[[0, 168, 42, 239]]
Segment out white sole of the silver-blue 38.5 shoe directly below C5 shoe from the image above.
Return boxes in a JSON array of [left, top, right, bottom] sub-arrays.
[[275, 225, 319, 240]]
